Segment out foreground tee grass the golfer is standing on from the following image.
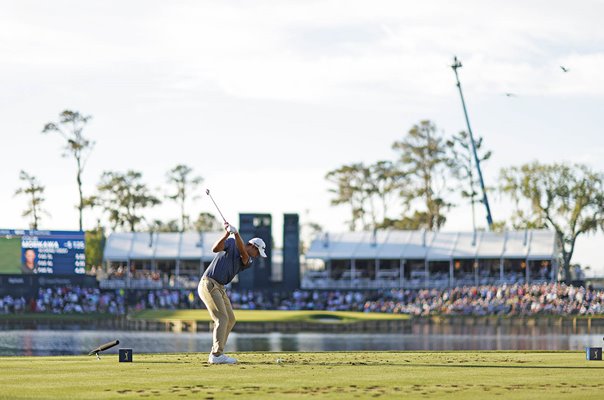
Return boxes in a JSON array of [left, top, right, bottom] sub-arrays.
[[0, 349, 604, 400]]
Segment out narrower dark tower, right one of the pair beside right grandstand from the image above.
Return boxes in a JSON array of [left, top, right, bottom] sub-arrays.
[[282, 214, 300, 290]]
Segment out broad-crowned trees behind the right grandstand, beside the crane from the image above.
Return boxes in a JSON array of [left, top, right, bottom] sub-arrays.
[[325, 120, 604, 277]]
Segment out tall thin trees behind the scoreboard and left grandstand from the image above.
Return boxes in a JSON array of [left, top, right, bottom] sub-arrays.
[[15, 110, 221, 232]]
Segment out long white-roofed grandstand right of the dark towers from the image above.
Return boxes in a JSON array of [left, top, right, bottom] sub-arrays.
[[301, 230, 559, 289]]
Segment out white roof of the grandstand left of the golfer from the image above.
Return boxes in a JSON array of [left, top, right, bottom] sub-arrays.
[[103, 232, 222, 262]]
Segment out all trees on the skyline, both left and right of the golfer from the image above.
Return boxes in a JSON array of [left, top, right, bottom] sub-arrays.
[[15, 110, 604, 276]]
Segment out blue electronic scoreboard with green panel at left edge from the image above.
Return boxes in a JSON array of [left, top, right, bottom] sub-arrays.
[[0, 229, 86, 275]]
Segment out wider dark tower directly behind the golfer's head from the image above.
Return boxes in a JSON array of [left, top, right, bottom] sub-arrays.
[[236, 214, 273, 289]]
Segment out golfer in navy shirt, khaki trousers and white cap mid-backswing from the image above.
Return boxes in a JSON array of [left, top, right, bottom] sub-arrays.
[[197, 222, 266, 364]]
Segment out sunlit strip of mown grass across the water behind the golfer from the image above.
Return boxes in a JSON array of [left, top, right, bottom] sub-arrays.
[[130, 310, 409, 323]]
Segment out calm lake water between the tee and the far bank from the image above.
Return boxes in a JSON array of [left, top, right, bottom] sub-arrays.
[[0, 326, 604, 356]]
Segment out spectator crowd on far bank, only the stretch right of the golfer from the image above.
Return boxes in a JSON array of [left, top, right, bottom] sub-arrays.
[[225, 283, 604, 316]]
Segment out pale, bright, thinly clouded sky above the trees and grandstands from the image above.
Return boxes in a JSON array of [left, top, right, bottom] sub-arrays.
[[0, 0, 604, 275]]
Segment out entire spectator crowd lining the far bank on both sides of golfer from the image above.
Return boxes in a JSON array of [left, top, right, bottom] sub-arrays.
[[0, 283, 604, 316]]
